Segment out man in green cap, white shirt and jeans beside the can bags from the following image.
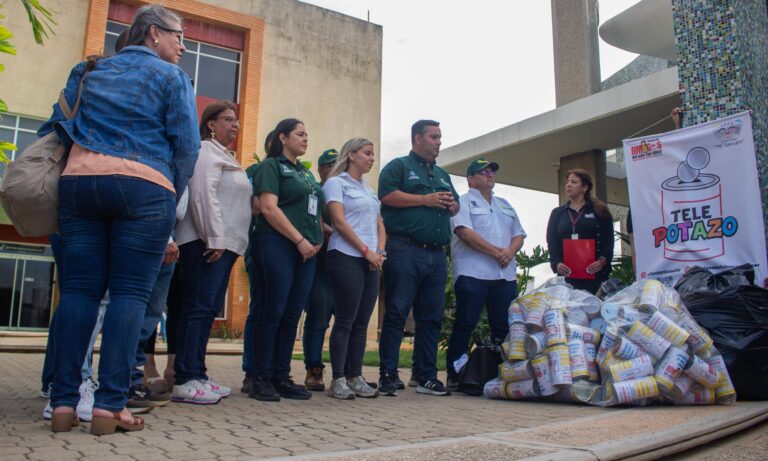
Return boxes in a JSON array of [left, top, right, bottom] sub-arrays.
[[446, 158, 526, 390]]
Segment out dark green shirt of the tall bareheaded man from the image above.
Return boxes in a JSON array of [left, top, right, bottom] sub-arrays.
[[379, 151, 459, 245]]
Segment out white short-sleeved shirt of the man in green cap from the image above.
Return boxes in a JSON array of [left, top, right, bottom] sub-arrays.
[[451, 189, 526, 282]]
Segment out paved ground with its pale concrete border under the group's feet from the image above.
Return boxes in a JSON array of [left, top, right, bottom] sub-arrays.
[[0, 353, 768, 461]]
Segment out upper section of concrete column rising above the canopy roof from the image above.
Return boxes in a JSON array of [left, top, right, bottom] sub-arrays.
[[551, 0, 600, 107]]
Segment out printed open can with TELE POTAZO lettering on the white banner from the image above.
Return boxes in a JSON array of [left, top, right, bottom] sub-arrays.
[[652, 147, 739, 262]]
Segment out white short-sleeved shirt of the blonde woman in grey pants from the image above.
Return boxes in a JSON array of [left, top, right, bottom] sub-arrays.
[[323, 172, 380, 257]]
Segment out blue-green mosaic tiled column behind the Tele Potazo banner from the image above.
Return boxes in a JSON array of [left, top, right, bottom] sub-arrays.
[[672, 0, 768, 241]]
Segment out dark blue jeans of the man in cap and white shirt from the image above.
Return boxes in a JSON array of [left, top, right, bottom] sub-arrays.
[[445, 275, 517, 372]]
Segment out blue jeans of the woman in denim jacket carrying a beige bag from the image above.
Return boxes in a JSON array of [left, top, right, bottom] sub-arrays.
[[51, 175, 176, 411]]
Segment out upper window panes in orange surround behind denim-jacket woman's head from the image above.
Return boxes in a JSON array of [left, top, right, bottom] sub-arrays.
[[104, 21, 242, 103]]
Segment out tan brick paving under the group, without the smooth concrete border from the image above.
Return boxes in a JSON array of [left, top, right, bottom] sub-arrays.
[[0, 353, 621, 461]]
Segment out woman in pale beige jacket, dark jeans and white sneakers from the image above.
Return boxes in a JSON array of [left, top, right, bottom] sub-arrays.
[[171, 101, 251, 405]]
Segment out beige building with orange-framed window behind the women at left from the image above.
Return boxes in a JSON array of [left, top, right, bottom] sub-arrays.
[[0, 0, 382, 332]]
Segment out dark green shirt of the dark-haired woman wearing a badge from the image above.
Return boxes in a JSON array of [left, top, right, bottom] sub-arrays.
[[253, 155, 324, 245]]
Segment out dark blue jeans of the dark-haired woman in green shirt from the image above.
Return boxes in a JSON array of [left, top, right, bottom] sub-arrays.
[[251, 232, 316, 381]]
